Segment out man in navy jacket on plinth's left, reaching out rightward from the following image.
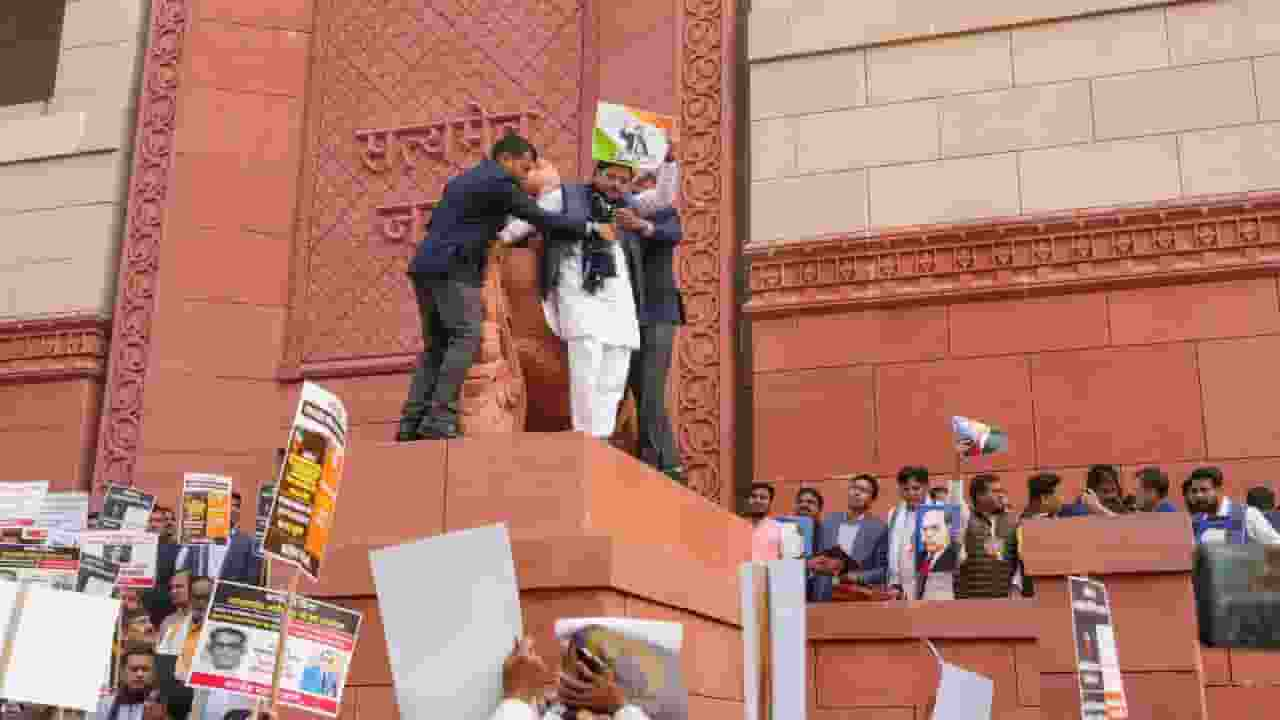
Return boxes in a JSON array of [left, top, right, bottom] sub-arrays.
[[396, 135, 591, 442]]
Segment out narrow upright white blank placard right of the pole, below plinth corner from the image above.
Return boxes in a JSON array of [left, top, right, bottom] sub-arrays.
[[769, 560, 808, 720]]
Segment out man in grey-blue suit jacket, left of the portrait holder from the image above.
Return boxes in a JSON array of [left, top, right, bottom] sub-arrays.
[[809, 475, 888, 602]]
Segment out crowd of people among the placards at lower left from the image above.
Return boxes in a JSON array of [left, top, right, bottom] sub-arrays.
[[0, 492, 270, 720]]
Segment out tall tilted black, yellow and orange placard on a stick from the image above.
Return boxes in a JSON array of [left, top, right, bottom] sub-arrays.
[[262, 383, 347, 580]]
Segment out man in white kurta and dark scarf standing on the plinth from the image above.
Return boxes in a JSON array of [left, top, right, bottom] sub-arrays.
[[498, 160, 678, 441]]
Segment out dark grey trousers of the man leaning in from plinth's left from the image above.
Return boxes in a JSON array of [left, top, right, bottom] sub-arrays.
[[401, 269, 484, 429]]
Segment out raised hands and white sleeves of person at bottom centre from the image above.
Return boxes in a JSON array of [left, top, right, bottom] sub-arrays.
[[490, 638, 649, 720]]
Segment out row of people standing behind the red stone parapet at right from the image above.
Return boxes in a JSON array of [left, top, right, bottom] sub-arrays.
[[745, 465, 1280, 602]]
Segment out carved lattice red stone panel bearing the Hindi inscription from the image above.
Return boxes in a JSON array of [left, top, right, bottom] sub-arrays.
[[285, 0, 584, 369]]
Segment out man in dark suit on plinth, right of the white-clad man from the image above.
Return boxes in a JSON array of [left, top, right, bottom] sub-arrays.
[[616, 143, 686, 484]]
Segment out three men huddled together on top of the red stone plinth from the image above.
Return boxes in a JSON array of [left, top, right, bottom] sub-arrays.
[[396, 135, 686, 484]]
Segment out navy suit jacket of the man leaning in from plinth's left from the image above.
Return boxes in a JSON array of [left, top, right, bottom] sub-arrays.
[[408, 159, 586, 279]]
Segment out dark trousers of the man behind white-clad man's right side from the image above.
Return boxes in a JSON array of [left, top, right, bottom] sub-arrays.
[[627, 323, 682, 470]]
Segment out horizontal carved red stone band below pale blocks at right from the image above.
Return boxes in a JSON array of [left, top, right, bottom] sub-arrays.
[[746, 193, 1280, 314]]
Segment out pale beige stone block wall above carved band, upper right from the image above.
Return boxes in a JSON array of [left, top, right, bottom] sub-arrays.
[[748, 0, 1280, 243]]
